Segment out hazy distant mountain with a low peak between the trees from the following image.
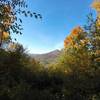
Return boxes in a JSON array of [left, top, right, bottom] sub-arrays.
[[31, 50, 61, 65]]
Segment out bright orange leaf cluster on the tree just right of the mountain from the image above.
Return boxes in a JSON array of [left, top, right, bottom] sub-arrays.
[[64, 26, 83, 48]]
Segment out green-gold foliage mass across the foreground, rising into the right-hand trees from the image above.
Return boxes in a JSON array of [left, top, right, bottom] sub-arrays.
[[0, 11, 100, 100]]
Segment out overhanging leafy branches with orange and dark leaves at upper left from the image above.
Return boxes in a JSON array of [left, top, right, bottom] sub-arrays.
[[0, 0, 42, 46]]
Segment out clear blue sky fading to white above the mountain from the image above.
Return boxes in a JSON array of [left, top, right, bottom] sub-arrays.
[[13, 0, 93, 53]]
